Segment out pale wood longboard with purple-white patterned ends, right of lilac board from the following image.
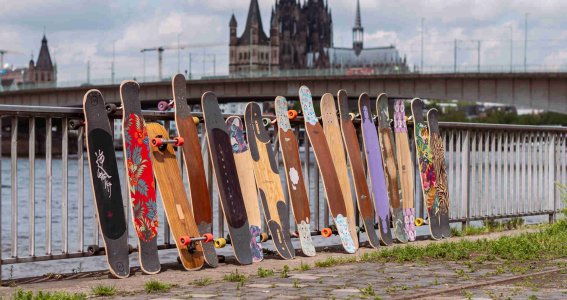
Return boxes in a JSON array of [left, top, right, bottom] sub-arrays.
[[393, 100, 416, 241]]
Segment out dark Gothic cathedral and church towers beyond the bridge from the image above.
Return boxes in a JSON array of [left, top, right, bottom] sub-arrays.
[[229, 0, 408, 74]]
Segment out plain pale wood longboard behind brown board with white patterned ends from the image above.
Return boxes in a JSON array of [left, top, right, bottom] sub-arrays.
[[321, 93, 358, 249]]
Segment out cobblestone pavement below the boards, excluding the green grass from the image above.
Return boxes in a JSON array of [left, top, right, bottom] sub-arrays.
[[0, 231, 567, 299]]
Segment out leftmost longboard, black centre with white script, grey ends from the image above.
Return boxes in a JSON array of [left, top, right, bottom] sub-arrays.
[[83, 90, 130, 278]]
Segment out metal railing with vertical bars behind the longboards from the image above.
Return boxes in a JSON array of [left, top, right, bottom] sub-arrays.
[[0, 105, 567, 279]]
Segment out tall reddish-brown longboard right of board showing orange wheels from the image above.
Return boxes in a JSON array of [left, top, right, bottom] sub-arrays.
[[172, 74, 219, 267]]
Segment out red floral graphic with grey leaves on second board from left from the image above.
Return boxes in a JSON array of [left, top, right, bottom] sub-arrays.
[[124, 114, 158, 242]]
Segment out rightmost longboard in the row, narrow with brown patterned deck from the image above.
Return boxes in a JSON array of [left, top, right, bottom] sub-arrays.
[[427, 108, 451, 237]]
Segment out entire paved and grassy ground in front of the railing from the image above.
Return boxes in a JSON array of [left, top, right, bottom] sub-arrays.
[[0, 221, 567, 299]]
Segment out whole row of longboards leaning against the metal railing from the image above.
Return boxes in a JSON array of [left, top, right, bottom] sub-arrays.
[[83, 74, 450, 278]]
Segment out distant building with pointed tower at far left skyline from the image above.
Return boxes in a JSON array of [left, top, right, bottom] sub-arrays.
[[0, 34, 57, 88]]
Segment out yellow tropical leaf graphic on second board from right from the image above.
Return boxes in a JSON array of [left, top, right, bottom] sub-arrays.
[[415, 123, 440, 217]]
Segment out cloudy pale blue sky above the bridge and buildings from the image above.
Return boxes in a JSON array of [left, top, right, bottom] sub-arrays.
[[0, 0, 567, 82]]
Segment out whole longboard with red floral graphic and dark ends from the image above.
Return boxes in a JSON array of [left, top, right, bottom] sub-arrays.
[[120, 81, 161, 274]]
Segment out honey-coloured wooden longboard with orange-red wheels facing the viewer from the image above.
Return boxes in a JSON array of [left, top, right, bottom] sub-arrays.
[[146, 123, 204, 270]]
